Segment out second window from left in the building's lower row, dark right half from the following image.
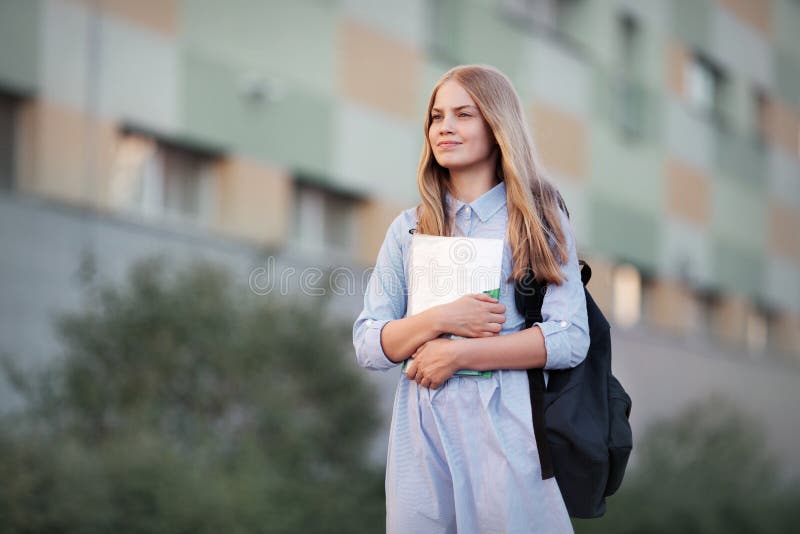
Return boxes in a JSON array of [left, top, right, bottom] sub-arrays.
[[111, 132, 216, 223]]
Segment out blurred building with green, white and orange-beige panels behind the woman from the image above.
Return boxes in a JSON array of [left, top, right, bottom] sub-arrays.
[[0, 0, 800, 473]]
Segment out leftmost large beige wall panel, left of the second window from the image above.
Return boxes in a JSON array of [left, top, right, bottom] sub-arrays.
[[20, 101, 116, 209]]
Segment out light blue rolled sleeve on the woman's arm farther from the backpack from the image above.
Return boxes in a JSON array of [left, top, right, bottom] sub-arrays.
[[353, 214, 406, 370]]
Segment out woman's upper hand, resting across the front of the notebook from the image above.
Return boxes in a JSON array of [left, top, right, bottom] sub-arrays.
[[438, 293, 506, 337]]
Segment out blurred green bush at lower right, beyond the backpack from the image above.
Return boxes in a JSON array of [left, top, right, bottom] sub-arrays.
[[574, 396, 800, 534]]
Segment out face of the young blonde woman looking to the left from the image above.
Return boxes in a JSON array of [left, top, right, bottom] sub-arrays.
[[428, 81, 495, 171]]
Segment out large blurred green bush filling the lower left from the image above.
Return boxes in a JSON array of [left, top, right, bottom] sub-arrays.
[[0, 259, 384, 533]]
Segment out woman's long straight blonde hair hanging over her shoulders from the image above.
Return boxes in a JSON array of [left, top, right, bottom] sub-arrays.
[[417, 65, 567, 285]]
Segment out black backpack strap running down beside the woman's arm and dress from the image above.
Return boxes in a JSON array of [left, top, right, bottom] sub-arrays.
[[520, 269, 554, 480]]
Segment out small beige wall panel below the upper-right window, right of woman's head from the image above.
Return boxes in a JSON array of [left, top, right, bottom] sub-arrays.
[[666, 158, 711, 227]]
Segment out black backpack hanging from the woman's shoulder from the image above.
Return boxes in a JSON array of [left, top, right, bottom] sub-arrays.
[[515, 261, 633, 519]]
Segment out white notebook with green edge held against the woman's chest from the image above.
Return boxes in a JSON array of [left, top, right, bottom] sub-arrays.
[[403, 234, 503, 382]]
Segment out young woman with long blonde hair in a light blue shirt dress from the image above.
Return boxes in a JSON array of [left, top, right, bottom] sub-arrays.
[[353, 65, 589, 534]]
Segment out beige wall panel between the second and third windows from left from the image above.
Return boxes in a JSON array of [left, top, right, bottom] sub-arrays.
[[216, 158, 292, 245]]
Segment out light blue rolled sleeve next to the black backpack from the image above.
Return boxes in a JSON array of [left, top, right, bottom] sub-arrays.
[[534, 212, 589, 370]]
